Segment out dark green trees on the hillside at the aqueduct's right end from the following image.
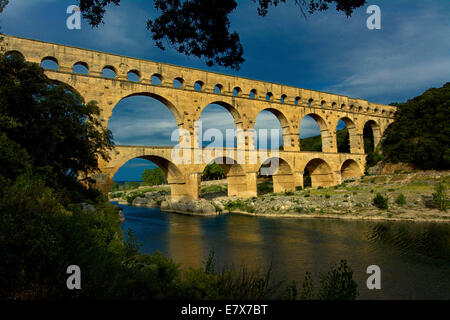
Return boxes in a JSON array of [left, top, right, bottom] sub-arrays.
[[382, 82, 450, 169]]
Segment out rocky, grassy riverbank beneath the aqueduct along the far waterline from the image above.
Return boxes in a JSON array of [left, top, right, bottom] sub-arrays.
[[111, 171, 450, 222]]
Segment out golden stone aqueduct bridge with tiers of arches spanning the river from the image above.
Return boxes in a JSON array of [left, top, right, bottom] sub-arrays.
[[0, 36, 396, 199]]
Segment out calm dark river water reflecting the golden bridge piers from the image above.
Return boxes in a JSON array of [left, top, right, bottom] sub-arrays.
[[114, 205, 450, 299]]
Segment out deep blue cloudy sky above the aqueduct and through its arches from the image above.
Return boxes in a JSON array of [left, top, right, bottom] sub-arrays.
[[0, 0, 450, 181]]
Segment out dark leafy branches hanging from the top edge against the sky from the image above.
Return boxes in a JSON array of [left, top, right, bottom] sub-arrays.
[[79, 0, 366, 70]]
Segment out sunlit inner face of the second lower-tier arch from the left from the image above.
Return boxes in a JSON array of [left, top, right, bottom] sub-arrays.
[[203, 156, 247, 197]]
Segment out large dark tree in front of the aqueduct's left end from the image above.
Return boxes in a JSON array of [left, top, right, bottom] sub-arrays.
[[0, 55, 113, 197]]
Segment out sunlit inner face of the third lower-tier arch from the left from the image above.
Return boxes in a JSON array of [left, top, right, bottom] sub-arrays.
[[258, 157, 295, 193]]
